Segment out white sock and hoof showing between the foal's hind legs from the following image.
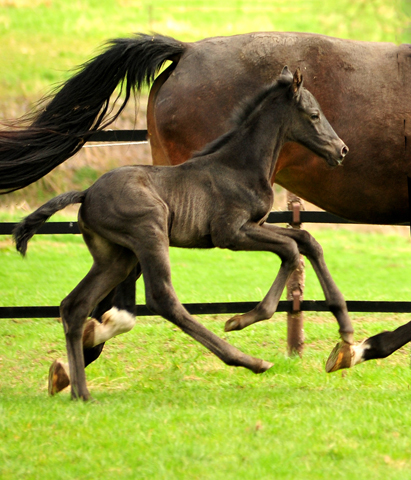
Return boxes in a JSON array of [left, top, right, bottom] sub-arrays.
[[93, 307, 136, 346]]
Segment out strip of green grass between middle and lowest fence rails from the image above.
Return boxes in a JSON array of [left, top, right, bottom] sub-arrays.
[[0, 220, 411, 306]]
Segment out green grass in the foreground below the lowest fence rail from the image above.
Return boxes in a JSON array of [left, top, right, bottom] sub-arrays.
[[0, 318, 411, 480]]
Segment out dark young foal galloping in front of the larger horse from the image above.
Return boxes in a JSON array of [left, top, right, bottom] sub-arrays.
[[14, 67, 353, 400]]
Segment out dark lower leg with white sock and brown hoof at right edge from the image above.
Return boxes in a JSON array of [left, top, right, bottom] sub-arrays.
[[325, 322, 411, 373]]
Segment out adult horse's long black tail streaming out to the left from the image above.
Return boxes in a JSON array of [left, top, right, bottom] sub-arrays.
[[0, 34, 186, 194]]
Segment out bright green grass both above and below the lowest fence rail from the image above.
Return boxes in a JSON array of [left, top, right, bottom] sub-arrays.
[[0, 229, 411, 480]]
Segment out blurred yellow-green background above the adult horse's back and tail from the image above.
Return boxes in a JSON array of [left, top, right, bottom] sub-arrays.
[[0, 0, 410, 98]]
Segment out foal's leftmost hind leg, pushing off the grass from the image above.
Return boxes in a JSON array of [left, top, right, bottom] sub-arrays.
[[60, 240, 137, 400]]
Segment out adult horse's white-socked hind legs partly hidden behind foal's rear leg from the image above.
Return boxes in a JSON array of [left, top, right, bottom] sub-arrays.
[[48, 265, 141, 395]]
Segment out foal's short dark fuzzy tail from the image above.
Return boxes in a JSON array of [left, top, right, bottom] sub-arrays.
[[13, 190, 87, 256]]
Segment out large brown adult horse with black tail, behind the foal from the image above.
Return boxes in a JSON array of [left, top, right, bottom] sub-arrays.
[[0, 32, 411, 374]]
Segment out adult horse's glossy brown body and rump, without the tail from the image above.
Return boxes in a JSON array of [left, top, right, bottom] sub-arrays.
[[147, 32, 411, 224]]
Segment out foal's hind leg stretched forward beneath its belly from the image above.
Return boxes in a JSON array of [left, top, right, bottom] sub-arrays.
[[135, 235, 272, 373]]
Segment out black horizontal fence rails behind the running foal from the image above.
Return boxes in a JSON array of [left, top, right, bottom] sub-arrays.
[[0, 130, 411, 318]]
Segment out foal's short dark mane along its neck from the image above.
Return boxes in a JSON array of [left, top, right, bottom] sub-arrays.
[[191, 75, 291, 158]]
